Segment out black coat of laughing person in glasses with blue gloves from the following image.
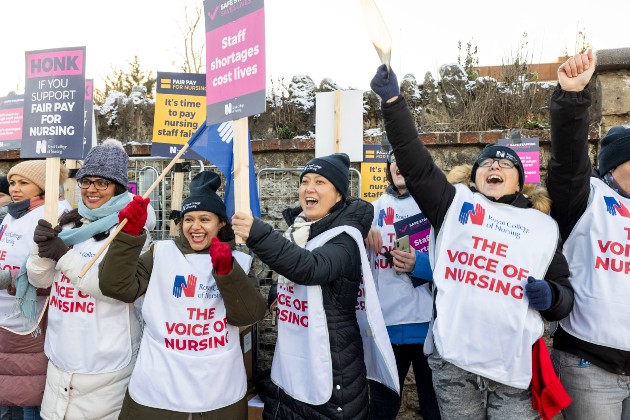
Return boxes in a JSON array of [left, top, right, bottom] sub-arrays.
[[383, 96, 573, 321]]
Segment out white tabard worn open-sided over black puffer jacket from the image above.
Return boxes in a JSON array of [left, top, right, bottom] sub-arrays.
[[271, 226, 400, 405]]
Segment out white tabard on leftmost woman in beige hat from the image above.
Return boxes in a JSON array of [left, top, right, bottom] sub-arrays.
[[0, 200, 71, 335]]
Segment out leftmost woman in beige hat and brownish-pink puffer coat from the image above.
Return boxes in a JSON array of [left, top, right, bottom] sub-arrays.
[[0, 160, 71, 419]]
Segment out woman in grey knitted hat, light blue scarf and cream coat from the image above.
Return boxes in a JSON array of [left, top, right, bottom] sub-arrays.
[[27, 140, 147, 419]]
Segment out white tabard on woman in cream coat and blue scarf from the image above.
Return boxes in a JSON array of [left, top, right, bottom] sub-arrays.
[[44, 231, 134, 373]]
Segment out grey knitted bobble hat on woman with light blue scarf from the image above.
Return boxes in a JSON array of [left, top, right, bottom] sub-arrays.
[[77, 140, 129, 188]]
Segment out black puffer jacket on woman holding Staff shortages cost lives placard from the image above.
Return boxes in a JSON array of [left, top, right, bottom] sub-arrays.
[[247, 198, 374, 419]]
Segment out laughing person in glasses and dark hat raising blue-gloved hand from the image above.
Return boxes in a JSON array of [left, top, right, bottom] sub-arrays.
[[371, 66, 573, 419]]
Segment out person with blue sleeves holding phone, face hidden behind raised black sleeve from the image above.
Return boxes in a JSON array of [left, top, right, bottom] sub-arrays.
[[366, 151, 440, 420]]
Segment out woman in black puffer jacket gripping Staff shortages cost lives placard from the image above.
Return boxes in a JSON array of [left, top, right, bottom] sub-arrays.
[[232, 153, 399, 419]]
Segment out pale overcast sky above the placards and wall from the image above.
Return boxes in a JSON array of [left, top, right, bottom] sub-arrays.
[[0, 0, 630, 96]]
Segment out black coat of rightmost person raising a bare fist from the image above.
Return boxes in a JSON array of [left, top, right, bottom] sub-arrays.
[[547, 86, 630, 375]]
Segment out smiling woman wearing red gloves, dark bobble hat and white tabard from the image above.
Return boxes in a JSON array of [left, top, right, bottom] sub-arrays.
[[99, 171, 266, 420]]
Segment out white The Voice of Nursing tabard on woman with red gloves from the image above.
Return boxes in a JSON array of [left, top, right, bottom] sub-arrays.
[[129, 240, 251, 413]]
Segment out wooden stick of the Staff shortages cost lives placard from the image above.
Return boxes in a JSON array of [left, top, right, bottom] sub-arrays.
[[233, 117, 251, 244]]
